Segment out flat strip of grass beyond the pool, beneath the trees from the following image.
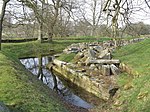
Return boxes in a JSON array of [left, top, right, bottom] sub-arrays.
[[2, 38, 110, 58]]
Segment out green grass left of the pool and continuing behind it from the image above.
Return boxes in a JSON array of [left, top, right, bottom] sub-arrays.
[[0, 39, 110, 112]]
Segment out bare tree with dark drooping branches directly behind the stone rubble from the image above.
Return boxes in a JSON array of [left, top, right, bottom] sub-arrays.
[[103, 0, 133, 47]]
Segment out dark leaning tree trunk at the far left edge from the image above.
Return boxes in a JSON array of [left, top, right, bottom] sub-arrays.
[[0, 0, 10, 50]]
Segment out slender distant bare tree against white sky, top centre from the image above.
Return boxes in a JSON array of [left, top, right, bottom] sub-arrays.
[[74, 0, 104, 36]]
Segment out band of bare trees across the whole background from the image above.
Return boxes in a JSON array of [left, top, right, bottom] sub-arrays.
[[0, 0, 150, 49]]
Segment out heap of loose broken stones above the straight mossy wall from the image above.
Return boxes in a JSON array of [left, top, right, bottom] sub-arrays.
[[63, 42, 120, 76]]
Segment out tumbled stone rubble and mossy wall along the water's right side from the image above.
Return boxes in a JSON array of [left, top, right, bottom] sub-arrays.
[[53, 38, 149, 100]]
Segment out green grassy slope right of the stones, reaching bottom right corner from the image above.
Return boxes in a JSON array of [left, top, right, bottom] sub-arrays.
[[114, 39, 150, 112]]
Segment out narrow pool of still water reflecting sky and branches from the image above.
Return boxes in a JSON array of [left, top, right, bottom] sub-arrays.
[[20, 56, 93, 109]]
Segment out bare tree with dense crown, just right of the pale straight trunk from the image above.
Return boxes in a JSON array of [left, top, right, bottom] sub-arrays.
[[44, 0, 72, 41]]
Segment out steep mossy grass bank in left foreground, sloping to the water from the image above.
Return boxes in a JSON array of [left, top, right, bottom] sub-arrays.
[[0, 52, 67, 112]]
